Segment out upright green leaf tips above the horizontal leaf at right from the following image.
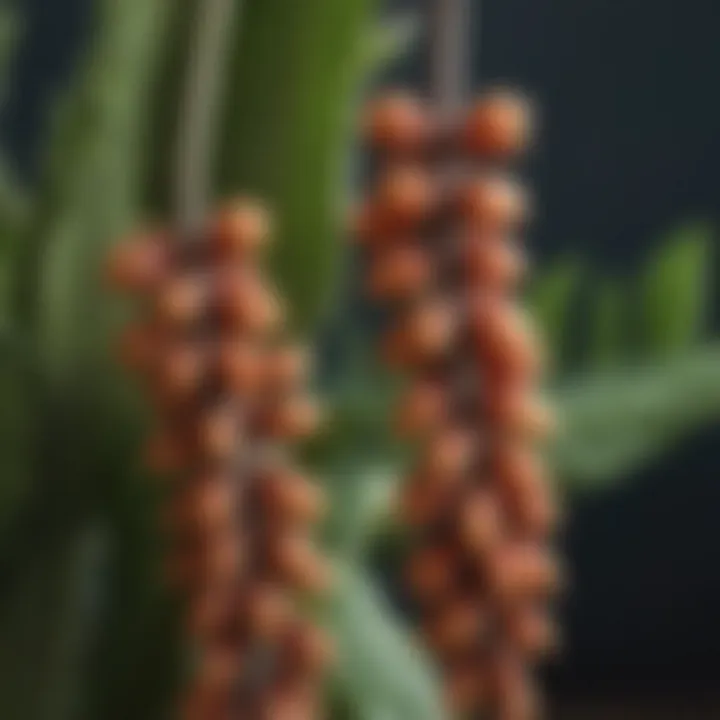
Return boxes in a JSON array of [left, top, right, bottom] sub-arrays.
[[528, 222, 714, 369]]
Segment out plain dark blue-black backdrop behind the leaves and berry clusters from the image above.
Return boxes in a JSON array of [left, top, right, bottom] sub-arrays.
[[8, 0, 720, 718]]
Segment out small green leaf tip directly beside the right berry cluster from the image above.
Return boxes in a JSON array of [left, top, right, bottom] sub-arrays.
[[528, 260, 583, 372]]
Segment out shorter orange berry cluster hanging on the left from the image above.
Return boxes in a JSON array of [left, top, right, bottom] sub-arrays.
[[109, 199, 332, 720]]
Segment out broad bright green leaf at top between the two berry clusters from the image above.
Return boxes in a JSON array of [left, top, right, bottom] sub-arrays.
[[220, 0, 376, 330]]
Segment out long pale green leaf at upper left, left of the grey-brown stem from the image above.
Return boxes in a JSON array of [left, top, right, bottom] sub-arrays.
[[19, 0, 173, 388]]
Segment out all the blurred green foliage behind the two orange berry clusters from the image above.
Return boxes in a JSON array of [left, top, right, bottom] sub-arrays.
[[0, 0, 720, 720]]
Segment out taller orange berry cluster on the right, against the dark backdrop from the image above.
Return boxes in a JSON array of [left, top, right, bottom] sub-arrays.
[[357, 91, 561, 720]]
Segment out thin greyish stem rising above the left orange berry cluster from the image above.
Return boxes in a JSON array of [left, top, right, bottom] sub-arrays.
[[175, 0, 242, 235]]
